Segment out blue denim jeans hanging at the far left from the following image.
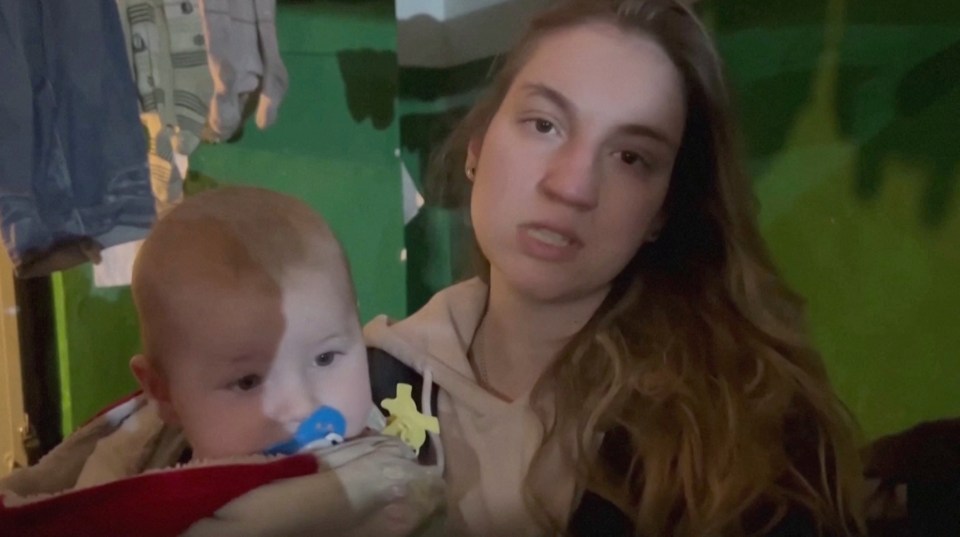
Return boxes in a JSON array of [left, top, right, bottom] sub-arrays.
[[0, 0, 155, 276]]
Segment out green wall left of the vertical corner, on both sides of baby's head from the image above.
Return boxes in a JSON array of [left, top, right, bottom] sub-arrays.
[[54, 0, 406, 433]]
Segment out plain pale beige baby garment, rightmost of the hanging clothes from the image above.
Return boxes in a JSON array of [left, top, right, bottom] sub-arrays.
[[200, 0, 288, 142]]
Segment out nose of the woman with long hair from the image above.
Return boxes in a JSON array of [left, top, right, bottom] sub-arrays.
[[538, 139, 601, 211]]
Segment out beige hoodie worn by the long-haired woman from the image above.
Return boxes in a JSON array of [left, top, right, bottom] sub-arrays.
[[363, 279, 575, 537]]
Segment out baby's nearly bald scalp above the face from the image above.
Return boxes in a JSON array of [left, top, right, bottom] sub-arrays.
[[132, 187, 355, 366]]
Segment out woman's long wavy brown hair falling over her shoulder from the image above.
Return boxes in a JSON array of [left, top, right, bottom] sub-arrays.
[[430, 0, 863, 537]]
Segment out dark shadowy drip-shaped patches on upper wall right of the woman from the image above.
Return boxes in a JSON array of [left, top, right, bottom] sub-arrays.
[[704, 0, 960, 228]]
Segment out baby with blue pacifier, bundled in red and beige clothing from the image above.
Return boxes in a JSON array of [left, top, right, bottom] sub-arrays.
[[0, 188, 444, 537]]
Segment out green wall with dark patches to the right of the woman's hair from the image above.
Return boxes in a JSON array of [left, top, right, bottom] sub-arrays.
[[705, 0, 960, 438]]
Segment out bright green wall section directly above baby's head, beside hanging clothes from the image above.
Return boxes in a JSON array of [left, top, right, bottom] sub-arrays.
[[190, 0, 406, 320]]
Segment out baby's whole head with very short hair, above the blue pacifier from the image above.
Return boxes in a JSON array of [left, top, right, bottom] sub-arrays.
[[130, 187, 372, 458]]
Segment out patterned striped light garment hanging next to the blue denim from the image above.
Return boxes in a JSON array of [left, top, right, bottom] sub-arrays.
[[116, 0, 213, 215]]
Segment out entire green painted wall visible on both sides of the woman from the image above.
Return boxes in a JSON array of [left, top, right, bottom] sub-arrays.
[[50, 0, 960, 437]]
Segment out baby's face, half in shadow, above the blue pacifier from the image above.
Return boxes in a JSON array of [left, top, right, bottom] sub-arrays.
[[158, 268, 372, 458]]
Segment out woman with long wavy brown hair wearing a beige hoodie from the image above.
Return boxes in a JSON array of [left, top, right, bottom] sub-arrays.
[[365, 0, 861, 536]]
